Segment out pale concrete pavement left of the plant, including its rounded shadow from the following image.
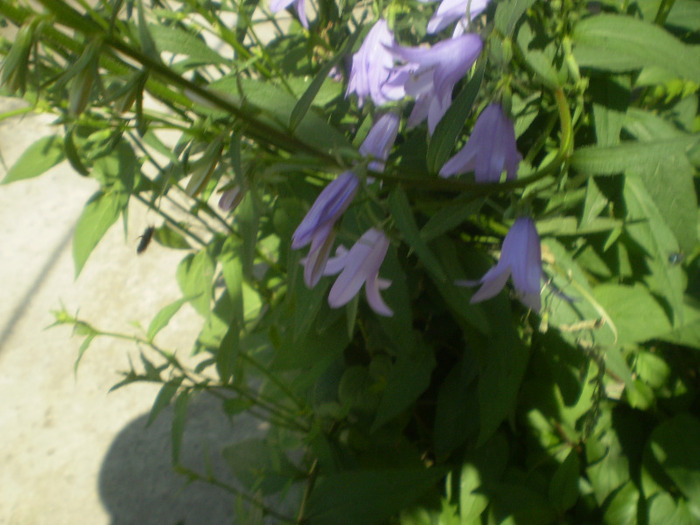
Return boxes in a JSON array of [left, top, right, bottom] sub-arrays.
[[0, 99, 270, 525]]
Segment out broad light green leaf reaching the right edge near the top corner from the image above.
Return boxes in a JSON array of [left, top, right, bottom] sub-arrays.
[[573, 14, 700, 82]]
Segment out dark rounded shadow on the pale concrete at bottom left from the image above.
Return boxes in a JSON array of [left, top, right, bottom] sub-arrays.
[[99, 396, 253, 525]]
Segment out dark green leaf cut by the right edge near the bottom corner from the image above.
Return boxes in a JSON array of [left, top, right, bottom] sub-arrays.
[[649, 414, 700, 520]]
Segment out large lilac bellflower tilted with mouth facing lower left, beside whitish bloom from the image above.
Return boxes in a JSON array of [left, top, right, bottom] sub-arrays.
[[388, 33, 483, 135]]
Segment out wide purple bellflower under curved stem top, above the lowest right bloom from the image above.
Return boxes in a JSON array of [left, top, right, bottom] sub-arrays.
[[440, 104, 523, 182]]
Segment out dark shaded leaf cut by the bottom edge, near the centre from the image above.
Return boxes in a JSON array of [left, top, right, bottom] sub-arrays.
[[306, 468, 444, 525]]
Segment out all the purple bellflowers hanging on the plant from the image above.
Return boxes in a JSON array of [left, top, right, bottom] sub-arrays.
[[282, 0, 541, 315]]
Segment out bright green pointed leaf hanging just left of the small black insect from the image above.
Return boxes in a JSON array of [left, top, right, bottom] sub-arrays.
[[73, 191, 129, 278]]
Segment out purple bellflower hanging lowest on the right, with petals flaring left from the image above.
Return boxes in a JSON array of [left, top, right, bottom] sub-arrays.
[[456, 217, 542, 311]]
